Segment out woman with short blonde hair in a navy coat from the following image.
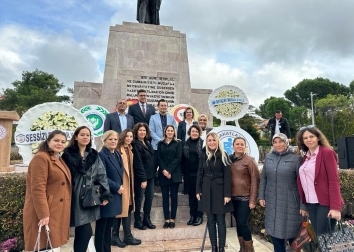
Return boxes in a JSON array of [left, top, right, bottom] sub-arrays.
[[95, 130, 124, 252]]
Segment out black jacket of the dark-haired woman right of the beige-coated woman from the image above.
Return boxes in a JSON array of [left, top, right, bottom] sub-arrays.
[[132, 140, 156, 183]]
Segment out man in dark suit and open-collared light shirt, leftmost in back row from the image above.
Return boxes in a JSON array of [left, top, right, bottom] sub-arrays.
[[103, 99, 134, 134]]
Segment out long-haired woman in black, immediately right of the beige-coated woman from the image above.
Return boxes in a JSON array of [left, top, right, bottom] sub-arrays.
[[132, 123, 156, 230]]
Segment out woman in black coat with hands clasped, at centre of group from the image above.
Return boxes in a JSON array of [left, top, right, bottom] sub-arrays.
[[157, 125, 182, 228]]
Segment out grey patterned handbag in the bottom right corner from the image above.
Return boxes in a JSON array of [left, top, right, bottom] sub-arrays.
[[318, 218, 354, 252]]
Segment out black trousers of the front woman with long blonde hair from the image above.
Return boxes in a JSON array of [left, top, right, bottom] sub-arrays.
[[207, 213, 226, 248]]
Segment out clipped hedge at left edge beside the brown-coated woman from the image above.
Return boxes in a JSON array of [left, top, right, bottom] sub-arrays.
[[0, 173, 26, 251]]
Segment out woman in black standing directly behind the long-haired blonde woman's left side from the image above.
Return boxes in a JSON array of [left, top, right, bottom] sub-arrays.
[[182, 125, 203, 226]]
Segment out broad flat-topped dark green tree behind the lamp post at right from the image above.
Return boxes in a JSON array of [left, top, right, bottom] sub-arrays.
[[284, 77, 350, 109]]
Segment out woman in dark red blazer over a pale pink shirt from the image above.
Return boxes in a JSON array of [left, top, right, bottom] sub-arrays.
[[297, 125, 343, 235]]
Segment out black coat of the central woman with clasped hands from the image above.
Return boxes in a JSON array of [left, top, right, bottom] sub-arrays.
[[157, 140, 182, 185]]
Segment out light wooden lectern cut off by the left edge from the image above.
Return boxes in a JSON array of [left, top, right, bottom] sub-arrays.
[[0, 111, 20, 172]]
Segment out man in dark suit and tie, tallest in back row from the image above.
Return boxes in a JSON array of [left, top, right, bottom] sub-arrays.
[[128, 89, 156, 125]]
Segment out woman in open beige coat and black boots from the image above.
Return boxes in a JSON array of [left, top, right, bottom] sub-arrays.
[[112, 129, 141, 248]]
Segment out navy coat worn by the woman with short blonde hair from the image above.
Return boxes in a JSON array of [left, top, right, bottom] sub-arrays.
[[98, 147, 124, 218]]
